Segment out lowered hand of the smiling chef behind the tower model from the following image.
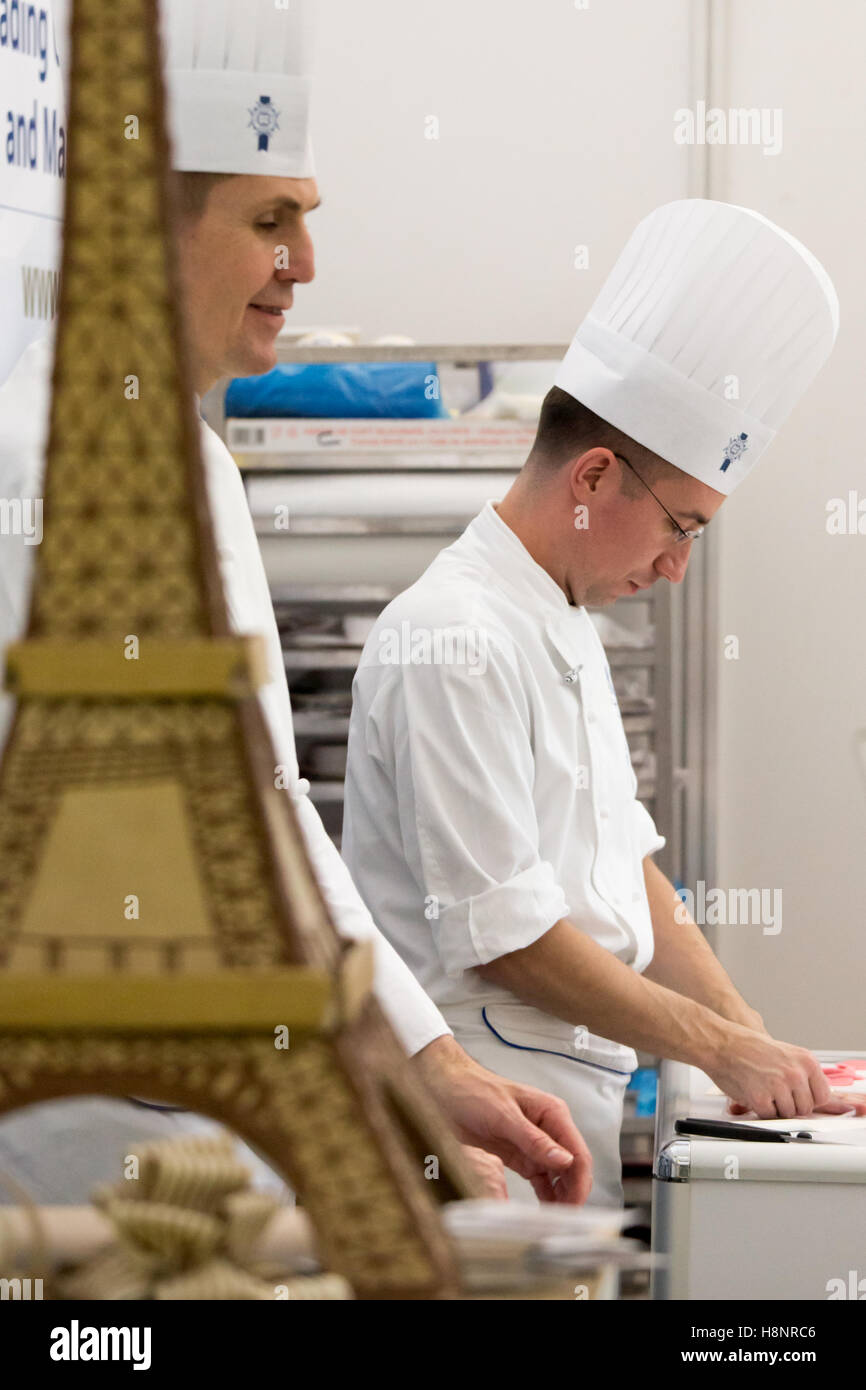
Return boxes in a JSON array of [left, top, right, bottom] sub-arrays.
[[411, 1034, 592, 1204]]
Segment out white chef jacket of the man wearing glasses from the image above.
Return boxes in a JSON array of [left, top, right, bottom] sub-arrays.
[[342, 502, 664, 1193]]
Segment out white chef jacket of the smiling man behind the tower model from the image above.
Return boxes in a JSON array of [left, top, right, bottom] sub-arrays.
[[0, 335, 450, 1055]]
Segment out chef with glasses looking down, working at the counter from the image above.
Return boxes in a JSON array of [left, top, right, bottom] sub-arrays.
[[342, 200, 861, 1204]]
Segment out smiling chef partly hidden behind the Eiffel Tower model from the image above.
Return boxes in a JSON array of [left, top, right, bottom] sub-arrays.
[[0, 0, 591, 1202]]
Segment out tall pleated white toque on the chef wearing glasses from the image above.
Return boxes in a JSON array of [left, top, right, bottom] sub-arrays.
[[556, 199, 838, 493]]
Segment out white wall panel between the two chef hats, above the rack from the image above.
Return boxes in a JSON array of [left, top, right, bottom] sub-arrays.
[[308, 0, 689, 342]]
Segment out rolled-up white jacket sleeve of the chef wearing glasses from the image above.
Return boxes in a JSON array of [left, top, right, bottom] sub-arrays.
[[367, 632, 569, 977]]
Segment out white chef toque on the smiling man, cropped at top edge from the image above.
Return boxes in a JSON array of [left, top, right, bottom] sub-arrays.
[[161, 0, 314, 178]]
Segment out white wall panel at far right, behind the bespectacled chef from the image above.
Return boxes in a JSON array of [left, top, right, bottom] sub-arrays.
[[712, 0, 866, 1048]]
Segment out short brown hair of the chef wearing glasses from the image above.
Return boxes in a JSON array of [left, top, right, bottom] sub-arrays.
[[527, 386, 680, 496]]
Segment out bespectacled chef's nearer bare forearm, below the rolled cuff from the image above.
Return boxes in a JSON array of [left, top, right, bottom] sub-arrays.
[[477, 919, 730, 1070]]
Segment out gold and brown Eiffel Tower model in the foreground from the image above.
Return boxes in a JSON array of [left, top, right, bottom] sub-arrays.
[[0, 0, 474, 1298]]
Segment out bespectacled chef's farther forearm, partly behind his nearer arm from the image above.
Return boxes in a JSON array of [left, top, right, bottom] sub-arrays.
[[644, 858, 763, 1027]]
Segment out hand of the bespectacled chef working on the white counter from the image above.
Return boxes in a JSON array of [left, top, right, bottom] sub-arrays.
[[705, 1023, 866, 1120]]
